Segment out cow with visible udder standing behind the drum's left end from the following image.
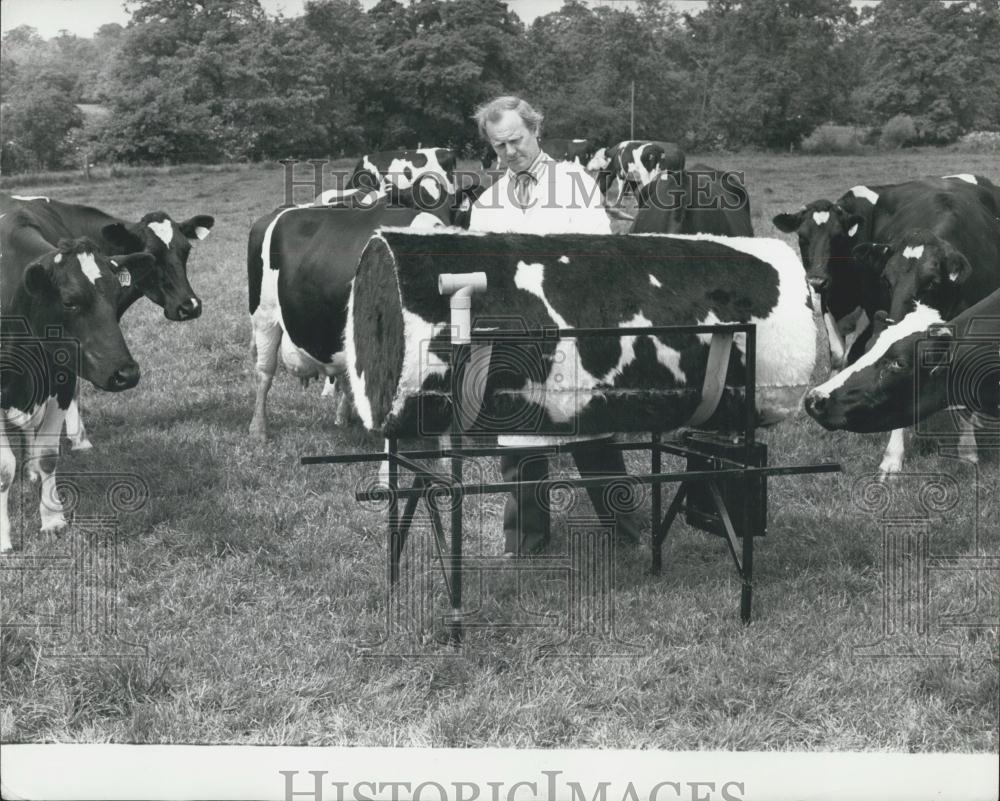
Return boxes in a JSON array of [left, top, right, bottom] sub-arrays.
[[247, 176, 482, 439]]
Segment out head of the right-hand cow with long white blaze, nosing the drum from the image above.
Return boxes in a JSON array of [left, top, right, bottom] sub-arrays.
[[805, 304, 952, 432]]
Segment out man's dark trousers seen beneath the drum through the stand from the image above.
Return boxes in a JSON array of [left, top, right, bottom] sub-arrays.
[[500, 438, 641, 554]]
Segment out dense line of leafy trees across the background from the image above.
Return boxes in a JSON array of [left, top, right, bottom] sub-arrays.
[[0, 0, 1000, 172]]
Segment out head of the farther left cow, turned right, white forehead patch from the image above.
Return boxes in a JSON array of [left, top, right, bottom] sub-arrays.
[[101, 211, 215, 320]]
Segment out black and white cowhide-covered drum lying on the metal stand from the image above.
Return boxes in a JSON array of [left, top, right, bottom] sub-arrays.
[[345, 228, 816, 437]]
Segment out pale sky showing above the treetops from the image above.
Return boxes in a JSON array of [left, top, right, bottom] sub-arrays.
[[0, 0, 688, 39]]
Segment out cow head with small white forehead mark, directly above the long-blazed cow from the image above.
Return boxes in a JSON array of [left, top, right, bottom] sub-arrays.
[[853, 228, 972, 322]]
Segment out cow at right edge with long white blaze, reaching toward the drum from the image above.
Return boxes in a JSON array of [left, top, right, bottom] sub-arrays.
[[805, 290, 1000, 461]]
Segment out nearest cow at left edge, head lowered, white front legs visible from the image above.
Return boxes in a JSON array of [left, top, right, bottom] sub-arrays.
[[0, 233, 153, 551]]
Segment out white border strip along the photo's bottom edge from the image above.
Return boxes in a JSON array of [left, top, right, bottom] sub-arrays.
[[0, 745, 1000, 801]]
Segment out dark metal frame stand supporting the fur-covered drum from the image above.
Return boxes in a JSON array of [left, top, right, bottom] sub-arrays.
[[301, 323, 841, 643]]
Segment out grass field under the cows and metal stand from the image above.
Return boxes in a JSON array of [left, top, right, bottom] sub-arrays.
[[0, 152, 1000, 752]]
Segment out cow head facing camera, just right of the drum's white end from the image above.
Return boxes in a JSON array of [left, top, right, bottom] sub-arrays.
[[772, 200, 864, 293]]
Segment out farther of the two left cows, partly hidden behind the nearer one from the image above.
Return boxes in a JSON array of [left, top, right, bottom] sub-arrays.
[[0, 193, 215, 450]]
